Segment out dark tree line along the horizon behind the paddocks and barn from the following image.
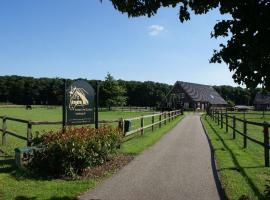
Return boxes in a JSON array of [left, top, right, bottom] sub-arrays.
[[0, 74, 260, 107]]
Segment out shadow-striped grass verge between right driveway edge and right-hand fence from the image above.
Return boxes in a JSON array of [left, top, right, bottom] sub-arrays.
[[202, 117, 270, 200]]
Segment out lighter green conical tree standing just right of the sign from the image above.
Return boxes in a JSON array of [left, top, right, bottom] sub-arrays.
[[102, 73, 127, 110]]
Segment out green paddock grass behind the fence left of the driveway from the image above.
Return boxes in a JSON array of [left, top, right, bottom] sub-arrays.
[[0, 106, 156, 154]]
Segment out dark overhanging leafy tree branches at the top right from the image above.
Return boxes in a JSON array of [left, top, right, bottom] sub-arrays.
[[107, 0, 270, 89]]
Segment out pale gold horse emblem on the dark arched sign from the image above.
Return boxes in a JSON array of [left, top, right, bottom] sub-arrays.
[[68, 86, 89, 110]]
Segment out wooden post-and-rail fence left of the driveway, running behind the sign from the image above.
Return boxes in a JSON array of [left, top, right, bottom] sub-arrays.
[[0, 110, 182, 146]]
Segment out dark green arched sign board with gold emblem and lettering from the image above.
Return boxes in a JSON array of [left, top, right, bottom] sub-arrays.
[[65, 80, 95, 125]]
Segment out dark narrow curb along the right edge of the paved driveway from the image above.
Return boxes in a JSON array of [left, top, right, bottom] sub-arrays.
[[200, 115, 228, 200]]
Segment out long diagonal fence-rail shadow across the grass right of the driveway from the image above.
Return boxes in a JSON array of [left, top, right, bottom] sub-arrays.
[[206, 119, 265, 199]]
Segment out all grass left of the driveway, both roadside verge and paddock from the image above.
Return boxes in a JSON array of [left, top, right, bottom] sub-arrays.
[[0, 108, 183, 200]]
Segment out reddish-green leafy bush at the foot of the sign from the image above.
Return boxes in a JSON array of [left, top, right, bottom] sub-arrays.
[[30, 126, 122, 177]]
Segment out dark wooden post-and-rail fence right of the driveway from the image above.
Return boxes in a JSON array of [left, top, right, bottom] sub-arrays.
[[211, 110, 270, 167]]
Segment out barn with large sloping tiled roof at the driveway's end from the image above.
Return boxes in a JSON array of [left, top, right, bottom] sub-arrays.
[[165, 81, 228, 111]]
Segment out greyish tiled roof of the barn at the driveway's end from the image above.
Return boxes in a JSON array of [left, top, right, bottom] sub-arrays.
[[176, 81, 227, 105]]
